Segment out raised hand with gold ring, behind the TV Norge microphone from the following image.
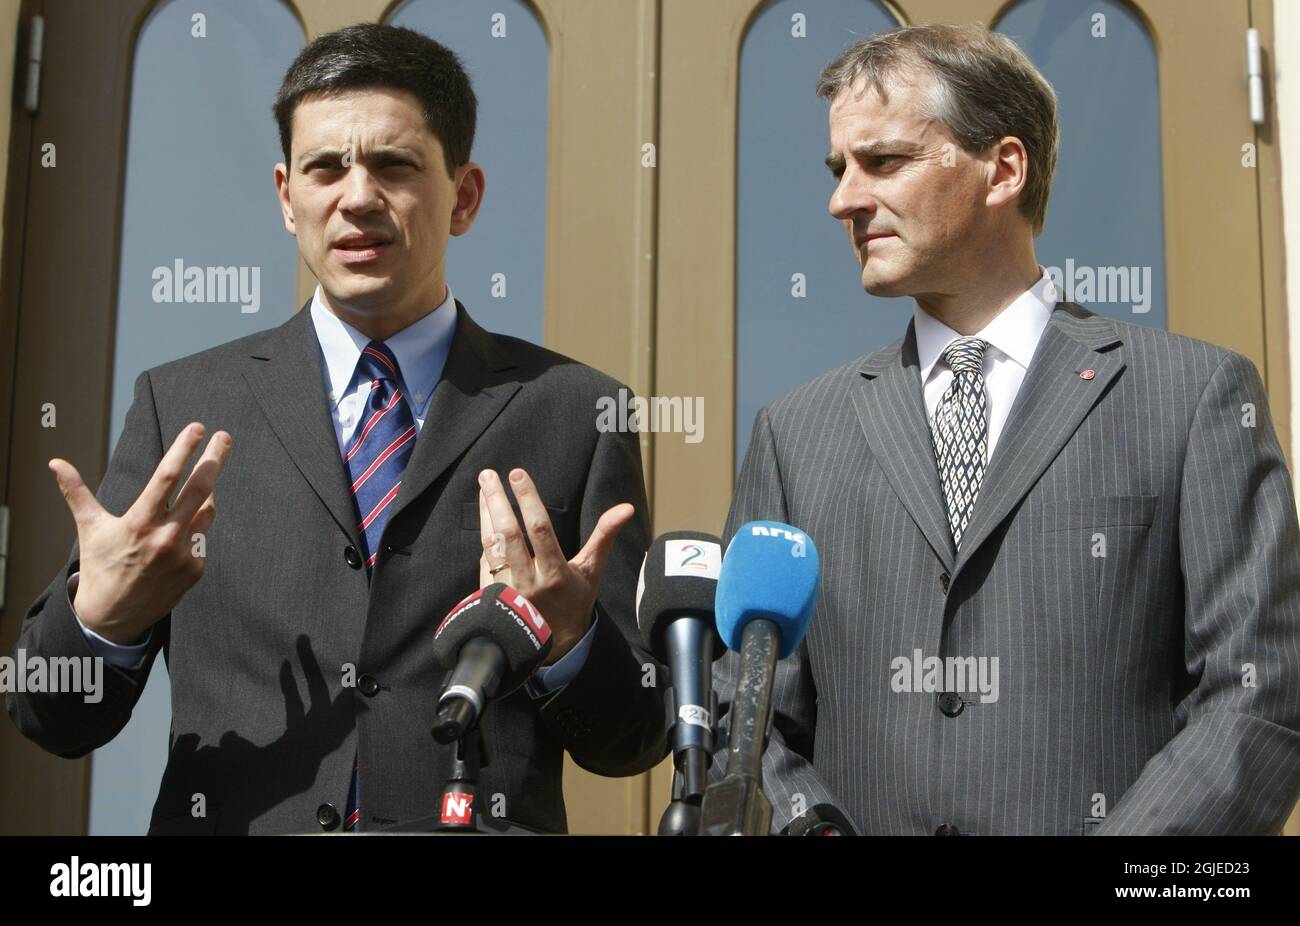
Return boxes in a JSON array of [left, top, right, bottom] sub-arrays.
[[478, 470, 636, 665]]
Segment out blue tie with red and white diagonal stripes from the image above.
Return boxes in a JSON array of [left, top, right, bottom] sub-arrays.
[[343, 341, 416, 830]]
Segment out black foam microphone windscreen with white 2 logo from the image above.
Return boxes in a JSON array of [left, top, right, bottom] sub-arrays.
[[637, 531, 727, 662]]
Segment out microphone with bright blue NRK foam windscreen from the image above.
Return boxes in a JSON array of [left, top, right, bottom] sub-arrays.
[[701, 522, 822, 836]]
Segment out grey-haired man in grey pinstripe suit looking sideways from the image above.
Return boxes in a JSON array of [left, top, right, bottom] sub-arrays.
[[719, 26, 1300, 835]]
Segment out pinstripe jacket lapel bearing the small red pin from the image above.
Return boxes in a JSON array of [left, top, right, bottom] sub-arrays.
[[951, 302, 1125, 580]]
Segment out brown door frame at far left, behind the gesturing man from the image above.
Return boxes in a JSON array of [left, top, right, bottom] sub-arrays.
[[0, 0, 152, 835]]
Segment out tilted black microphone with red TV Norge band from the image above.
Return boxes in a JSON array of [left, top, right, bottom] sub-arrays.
[[433, 583, 551, 744]]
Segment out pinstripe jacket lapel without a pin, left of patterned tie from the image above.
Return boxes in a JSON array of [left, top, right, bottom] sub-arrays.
[[853, 321, 956, 570]]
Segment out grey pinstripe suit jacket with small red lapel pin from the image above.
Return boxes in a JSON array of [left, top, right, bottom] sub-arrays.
[[719, 303, 1300, 834]]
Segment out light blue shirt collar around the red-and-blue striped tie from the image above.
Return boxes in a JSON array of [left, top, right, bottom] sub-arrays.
[[311, 285, 456, 410]]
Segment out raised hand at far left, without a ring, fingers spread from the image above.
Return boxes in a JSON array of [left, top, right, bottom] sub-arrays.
[[48, 421, 230, 644]]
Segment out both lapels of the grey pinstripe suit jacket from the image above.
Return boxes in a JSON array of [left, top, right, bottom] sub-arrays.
[[853, 303, 1125, 580]]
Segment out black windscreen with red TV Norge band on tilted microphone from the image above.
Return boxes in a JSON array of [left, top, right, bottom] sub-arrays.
[[433, 583, 551, 697]]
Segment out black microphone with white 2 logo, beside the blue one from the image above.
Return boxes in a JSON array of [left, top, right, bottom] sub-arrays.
[[637, 531, 727, 836]]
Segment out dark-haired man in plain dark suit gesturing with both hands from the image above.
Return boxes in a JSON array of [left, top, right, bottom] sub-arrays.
[[8, 25, 664, 834]]
